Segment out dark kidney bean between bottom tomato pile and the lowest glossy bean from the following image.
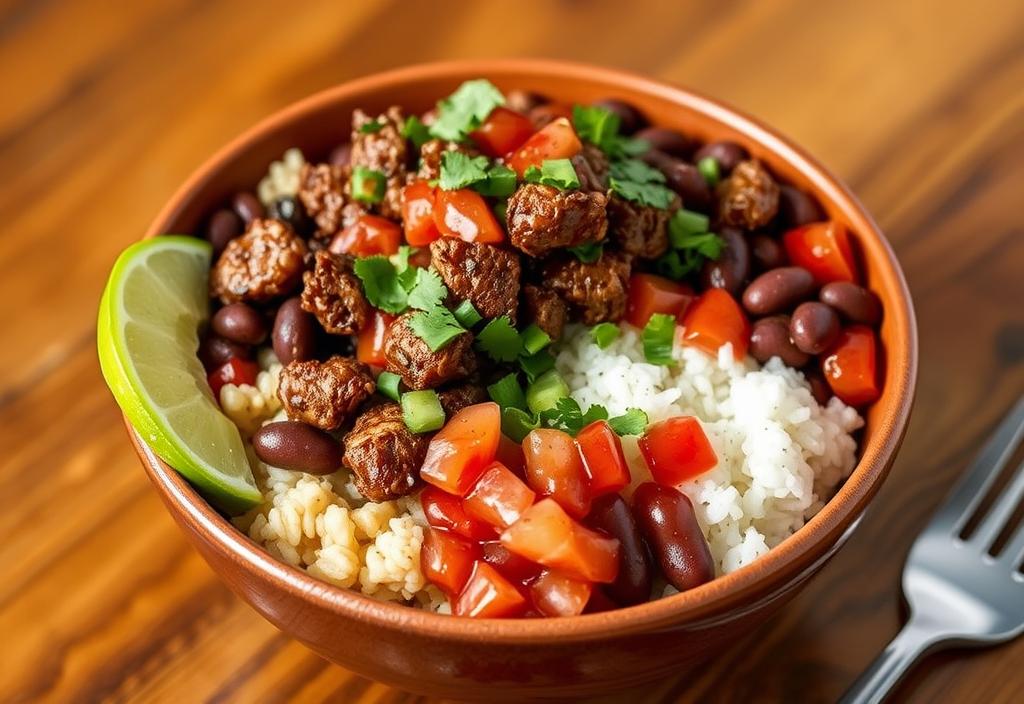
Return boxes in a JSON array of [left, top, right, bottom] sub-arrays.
[[587, 494, 652, 606]]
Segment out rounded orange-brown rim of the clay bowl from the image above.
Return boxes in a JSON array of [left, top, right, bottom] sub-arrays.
[[125, 59, 918, 644]]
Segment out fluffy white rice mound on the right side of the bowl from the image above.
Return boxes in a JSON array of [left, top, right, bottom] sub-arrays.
[[556, 325, 863, 574]]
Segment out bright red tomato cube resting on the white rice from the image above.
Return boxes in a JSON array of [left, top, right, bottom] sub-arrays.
[[639, 415, 718, 487]]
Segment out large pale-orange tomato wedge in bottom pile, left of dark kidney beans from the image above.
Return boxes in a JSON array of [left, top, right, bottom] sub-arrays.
[[502, 498, 618, 582]]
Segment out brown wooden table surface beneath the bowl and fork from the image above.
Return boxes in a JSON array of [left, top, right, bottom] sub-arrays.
[[0, 0, 1024, 702]]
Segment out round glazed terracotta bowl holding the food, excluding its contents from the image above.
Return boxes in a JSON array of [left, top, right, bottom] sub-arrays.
[[131, 60, 918, 700]]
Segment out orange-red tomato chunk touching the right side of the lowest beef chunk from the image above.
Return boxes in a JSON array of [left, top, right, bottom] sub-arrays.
[[420, 401, 502, 496]]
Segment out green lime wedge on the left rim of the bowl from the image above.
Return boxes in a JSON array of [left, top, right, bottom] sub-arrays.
[[96, 235, 260, 514]]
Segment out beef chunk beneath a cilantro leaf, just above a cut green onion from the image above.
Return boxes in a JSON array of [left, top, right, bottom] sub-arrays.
[[384, 313, 476, 389]]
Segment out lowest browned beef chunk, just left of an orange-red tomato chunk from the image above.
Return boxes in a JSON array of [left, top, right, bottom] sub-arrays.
[[342, 403, 430, 502]]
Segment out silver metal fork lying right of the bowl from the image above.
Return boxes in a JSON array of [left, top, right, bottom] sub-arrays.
[[841, 397, 1024, 704]]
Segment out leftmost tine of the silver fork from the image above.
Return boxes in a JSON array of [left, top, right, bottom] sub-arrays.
[[932, 397, 1024, 535]]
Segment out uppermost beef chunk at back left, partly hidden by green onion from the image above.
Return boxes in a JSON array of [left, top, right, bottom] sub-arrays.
[[351, 105, 409, 220]]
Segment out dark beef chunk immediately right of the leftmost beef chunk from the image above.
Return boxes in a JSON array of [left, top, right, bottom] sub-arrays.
[[302, 251, 373, 335]]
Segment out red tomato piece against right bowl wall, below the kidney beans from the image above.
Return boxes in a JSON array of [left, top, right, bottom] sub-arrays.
[[821, 325, 882, 406]]
